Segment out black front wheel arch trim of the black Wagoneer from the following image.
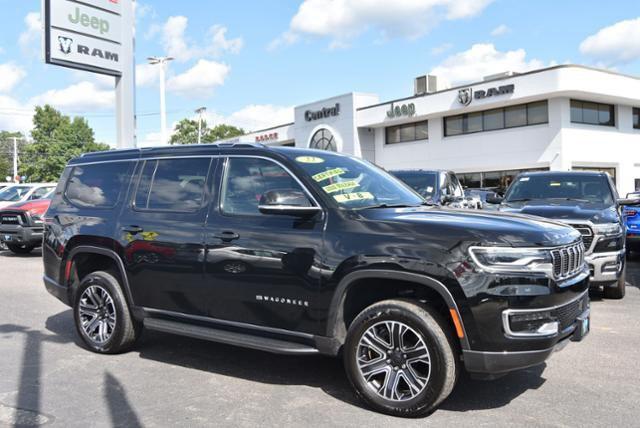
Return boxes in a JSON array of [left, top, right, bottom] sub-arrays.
[[326, 269, 470, 350]]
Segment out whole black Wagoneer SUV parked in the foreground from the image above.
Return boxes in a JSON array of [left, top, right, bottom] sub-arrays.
[[43, 144, 589, 416]]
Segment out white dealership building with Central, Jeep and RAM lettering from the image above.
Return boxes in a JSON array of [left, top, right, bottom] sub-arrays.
[[221, 65, 640, 195]]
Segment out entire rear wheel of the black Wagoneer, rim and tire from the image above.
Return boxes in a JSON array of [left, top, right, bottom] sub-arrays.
[[73, 271, 140, 354]]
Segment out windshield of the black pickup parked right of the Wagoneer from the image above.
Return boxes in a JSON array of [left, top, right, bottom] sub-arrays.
[[505, 174, 613, 205]]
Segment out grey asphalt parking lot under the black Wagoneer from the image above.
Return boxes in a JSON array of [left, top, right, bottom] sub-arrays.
[[0, 251, 640, 427]]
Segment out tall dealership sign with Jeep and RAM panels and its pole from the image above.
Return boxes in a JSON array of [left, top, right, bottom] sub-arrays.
[[43, 0, 136, 148]]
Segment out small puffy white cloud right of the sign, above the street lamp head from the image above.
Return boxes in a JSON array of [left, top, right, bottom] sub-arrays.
[[160, 16, 243, 62]]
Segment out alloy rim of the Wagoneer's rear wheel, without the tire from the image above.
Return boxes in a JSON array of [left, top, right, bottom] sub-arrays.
[[78, 285, 116, 345]]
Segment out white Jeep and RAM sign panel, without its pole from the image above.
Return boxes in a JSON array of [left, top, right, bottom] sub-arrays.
[[44, 0, 126, 76]]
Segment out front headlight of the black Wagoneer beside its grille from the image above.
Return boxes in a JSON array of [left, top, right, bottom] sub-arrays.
[[469, 247, 553, 275]]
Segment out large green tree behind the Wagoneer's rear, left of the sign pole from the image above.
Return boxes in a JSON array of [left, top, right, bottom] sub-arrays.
[[20, 105, 110, 182]]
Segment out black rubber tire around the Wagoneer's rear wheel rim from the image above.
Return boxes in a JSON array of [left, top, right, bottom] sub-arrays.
[[73, 271, 141, 354]]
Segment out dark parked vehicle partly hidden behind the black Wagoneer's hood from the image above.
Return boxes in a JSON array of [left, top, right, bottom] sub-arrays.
[[389, 169, 482, 209]]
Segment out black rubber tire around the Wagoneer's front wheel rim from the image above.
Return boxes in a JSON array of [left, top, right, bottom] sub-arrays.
[[344, 300, 460, 417]]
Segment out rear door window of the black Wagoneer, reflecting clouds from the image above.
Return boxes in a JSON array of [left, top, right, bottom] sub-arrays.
[[134, 158, 211, 211]]
